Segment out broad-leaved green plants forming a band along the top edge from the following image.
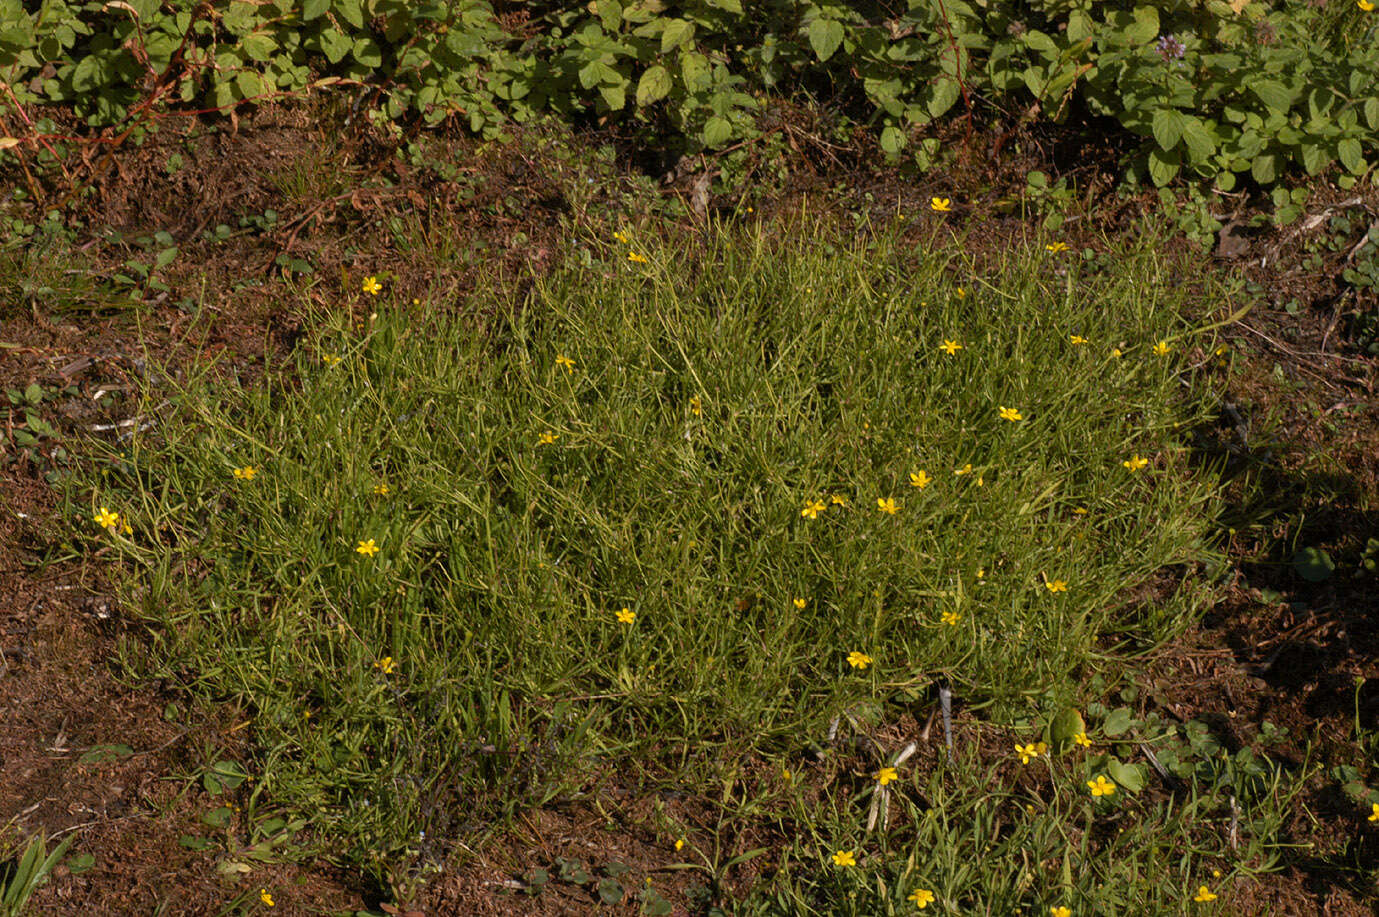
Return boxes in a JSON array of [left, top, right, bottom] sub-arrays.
[[0, 0, 1379, 190]]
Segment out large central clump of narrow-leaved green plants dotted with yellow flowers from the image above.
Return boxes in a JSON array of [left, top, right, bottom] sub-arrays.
[[70, 220, 1214, 862]]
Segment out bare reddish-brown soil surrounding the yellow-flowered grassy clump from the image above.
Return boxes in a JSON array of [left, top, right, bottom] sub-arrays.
[[0, 110, 1379, 916]]
